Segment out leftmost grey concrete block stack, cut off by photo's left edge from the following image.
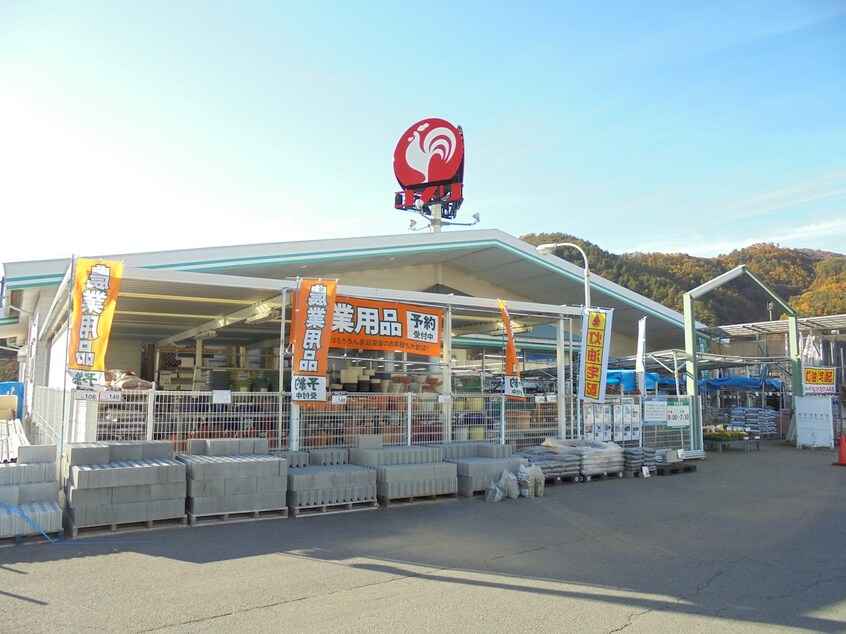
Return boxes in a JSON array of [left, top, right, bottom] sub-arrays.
[[0, 445, 62, 538]]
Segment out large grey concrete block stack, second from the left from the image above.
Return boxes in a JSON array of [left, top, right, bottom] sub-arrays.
[[63, 440, 186, 536]]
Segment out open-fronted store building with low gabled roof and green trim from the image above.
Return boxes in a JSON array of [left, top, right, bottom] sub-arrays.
[[0, 230, 684, 452]]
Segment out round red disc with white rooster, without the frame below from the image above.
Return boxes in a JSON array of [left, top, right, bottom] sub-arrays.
[[394, 119, 464, 189]]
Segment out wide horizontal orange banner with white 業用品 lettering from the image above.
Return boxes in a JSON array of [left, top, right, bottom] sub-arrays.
[[331, 297, 444, 357]]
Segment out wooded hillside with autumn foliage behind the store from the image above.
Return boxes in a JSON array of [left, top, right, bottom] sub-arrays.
[[521, 233, 846, 326]]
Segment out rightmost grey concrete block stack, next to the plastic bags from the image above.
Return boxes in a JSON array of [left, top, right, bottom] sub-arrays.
[[435, 442, 529, 497]]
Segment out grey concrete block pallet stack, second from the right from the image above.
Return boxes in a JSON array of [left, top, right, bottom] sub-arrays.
[[350, 443, 458, 505]]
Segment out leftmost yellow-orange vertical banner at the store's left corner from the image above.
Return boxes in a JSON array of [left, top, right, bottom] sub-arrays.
[[68, 258, 123, 389]]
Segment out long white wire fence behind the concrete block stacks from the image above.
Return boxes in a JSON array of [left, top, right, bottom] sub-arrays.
[[31, 388, 577, 451]]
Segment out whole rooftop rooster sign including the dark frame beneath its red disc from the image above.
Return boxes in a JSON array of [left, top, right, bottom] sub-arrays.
[[394, 119, 464, 218]]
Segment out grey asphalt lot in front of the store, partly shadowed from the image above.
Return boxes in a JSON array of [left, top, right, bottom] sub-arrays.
[[0, 441, 846, 634]]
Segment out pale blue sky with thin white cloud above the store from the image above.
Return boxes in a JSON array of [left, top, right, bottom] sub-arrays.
[[0, 0, 846, 262]]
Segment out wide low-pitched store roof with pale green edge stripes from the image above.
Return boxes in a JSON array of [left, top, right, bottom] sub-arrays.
[[0, 230, 684, 348]]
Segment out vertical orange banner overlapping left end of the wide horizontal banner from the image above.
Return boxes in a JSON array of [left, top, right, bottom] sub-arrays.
[[291, 279, 338, 403]]
